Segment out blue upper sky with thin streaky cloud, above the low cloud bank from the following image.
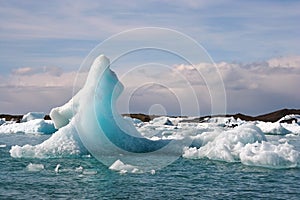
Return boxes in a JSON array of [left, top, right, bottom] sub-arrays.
[[0, 0, 300, 78]]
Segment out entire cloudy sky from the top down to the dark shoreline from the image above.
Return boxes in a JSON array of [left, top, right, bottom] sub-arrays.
[[0, 0, 300, 115]]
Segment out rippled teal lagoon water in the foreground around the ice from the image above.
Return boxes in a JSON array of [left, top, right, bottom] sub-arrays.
[[0, 134, 300, 199]]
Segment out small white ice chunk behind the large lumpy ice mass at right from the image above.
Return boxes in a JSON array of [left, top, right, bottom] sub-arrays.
[[257, 122, 291, 135]]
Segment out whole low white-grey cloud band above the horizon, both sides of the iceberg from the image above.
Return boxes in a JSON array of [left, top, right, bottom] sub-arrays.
[[0, 56, 300, 115]]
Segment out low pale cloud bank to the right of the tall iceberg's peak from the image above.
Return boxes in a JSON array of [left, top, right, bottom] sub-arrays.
[[117, 56, 300, 115]]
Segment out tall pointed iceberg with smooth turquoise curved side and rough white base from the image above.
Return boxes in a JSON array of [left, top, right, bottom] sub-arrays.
[[10, 55, 179, 165]]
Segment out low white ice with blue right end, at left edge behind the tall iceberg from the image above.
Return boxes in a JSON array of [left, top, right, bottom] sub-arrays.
[[0, 119, 56, 134]]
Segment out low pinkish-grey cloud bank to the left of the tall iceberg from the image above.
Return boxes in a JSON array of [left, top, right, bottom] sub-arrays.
[[0, 67, 87, 114]]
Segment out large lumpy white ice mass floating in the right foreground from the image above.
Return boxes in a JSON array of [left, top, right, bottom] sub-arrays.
[[183, 125, 300, 168]]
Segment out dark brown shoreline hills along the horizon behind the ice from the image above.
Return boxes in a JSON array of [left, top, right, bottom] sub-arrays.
[[0, 109, 300, 123]]
